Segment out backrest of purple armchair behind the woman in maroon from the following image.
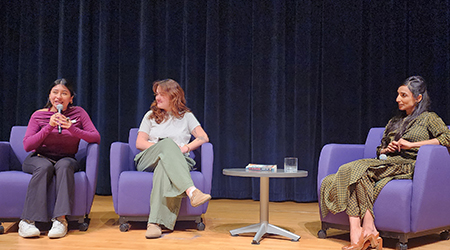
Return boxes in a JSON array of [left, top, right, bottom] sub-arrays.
[[9, 126, 88, 164]]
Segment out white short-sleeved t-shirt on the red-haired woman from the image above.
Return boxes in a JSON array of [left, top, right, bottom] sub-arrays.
[[139, 110, 200, 147]]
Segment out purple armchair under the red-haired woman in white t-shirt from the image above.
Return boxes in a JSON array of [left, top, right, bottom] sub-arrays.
[[110, 128, 214, 232]]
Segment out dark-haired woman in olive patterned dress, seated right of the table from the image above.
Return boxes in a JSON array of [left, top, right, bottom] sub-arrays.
[[320, 76, 450, 250]]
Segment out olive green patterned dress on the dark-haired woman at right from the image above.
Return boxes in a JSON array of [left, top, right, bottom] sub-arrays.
[[320, 112, 450, 218]]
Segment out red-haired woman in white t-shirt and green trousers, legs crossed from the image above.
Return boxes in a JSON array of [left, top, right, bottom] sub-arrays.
[[134, 79, 211, 239]]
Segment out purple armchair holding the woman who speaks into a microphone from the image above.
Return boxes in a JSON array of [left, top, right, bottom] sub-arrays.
[[0, 126, 99, 233]]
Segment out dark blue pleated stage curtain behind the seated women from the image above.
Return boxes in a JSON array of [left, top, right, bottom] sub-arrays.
[[0, 0, 450, 202]]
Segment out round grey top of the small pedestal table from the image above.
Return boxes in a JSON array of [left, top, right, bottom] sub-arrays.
[[222, 168, 308, 178]]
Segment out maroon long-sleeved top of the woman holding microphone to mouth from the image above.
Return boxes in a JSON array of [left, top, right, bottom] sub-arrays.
[[23, 106, 100, 159]]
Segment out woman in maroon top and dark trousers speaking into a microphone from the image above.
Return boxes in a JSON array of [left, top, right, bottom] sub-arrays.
[[19, 79, 100, 238]]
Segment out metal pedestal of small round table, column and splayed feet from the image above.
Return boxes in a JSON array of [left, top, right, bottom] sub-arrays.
[[230, 177, 300, 244]]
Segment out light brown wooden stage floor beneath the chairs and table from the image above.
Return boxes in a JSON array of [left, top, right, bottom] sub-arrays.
[[0, 196, 450, 250]]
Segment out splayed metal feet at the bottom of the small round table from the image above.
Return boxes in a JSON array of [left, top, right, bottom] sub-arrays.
[[230, 222, 300, 244]]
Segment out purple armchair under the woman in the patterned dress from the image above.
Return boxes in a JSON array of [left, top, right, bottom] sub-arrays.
[[317, 128, 450, 249]]
